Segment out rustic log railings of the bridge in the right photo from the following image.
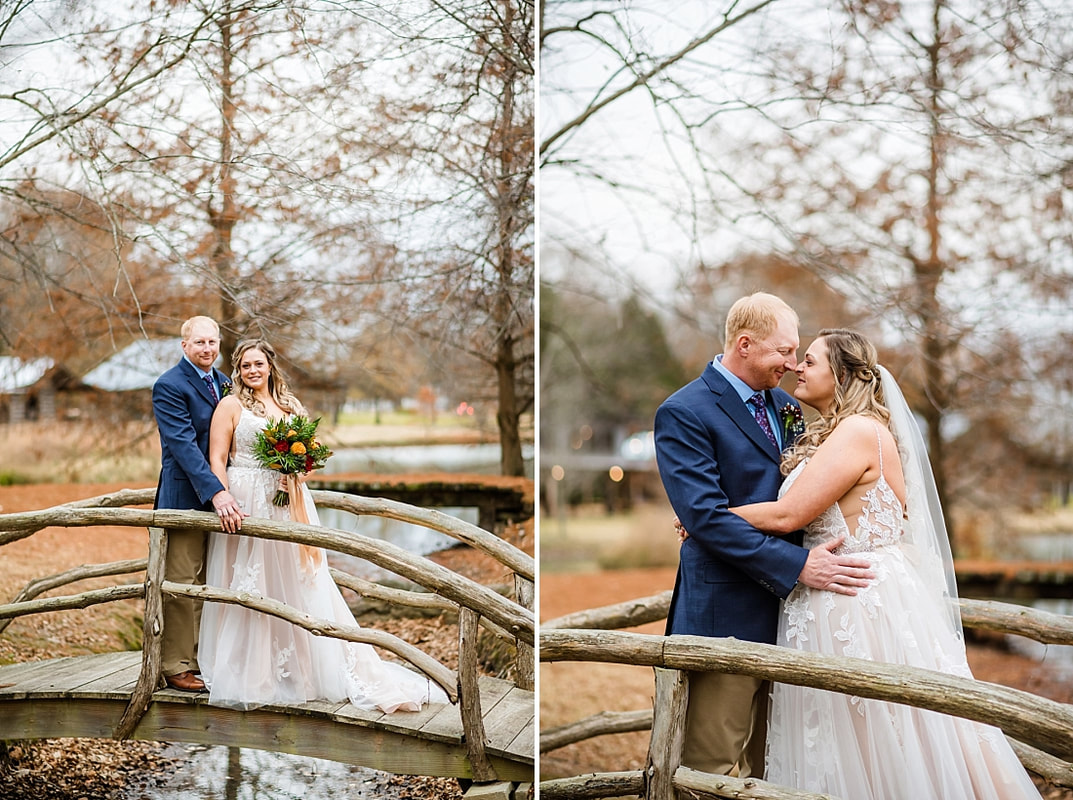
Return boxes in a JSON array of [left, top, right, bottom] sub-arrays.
[[540, 591, 1073, 800]]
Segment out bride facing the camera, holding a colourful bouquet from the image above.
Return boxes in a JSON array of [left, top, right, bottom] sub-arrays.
[[199, 340, 446, 713]]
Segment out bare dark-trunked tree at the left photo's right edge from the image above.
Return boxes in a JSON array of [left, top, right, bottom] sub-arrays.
[[369, 0, 535, 475]]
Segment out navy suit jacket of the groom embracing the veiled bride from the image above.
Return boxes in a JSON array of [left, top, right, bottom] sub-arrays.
[[656, 364, 808, 643]]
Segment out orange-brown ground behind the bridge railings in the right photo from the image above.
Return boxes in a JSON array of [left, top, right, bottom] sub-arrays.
[[540, 568, 1073, 800]]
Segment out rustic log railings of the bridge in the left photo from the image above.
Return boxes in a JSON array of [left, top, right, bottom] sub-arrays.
[[0, 489, 535, 781]]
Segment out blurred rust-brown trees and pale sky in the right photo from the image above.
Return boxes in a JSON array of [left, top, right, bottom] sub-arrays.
[[540, 0, 1073, 536]]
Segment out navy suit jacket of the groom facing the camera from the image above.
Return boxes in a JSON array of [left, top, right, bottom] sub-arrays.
[[152, 358, 231, 512]]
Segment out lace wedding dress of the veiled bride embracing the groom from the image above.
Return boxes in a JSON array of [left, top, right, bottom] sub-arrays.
[[766, 424, 1040, 800]]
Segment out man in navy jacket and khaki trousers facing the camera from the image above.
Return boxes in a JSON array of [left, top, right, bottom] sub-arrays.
[[152, 316, 249, 692]]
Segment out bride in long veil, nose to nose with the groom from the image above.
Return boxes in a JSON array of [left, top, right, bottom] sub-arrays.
[[731, 329, 1040, 800]]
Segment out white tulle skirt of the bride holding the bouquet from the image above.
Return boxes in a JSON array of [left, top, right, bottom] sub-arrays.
[[199, 468, 446, 712]]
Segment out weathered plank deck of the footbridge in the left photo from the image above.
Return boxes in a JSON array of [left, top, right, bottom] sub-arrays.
[[0, 652, 534, 782]]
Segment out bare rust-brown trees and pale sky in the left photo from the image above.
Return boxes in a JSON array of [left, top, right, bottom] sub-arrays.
[[0, 0, 534, 474]]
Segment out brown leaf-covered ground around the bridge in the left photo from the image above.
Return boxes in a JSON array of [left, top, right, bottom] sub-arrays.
[[0, 476, 533, 800]]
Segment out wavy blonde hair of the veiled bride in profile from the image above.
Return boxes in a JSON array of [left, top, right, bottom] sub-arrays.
[[781, 328, 891, 475]]
